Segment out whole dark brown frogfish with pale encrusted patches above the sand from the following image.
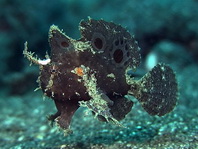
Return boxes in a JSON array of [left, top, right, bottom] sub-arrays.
[[23, 18, 178, 131]]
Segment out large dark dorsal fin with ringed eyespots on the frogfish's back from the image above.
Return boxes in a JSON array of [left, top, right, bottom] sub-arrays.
[[80, 18, 140, 69]]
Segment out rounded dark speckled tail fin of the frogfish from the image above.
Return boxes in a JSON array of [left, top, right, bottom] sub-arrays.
[[130, 63, 178, 116]]
